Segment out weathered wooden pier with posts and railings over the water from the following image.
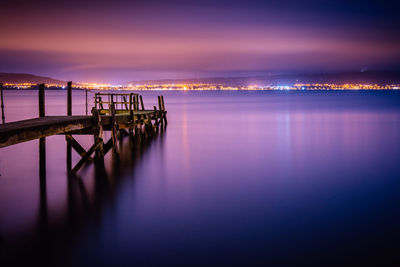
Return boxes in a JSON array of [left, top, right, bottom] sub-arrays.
[[0, 82, 167, 176]]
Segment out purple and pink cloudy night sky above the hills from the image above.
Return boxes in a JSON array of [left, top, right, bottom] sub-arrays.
[[0, 0, 400, 83]]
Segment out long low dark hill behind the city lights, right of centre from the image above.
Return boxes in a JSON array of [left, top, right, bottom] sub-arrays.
[[129, 71, 400, 86]]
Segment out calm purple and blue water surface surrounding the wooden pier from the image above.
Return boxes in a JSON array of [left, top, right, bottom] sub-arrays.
[[0, 91, 400, 266]]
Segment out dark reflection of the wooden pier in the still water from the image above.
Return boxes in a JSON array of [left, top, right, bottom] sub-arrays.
[[0, 125, 167, 265]]
